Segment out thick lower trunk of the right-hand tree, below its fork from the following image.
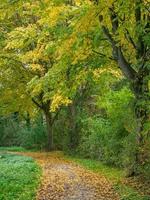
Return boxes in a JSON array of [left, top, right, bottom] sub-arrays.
[[128, 68, 150, 176]]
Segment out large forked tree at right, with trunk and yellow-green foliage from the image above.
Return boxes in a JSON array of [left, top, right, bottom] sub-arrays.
[[60, 0, 150, 175]]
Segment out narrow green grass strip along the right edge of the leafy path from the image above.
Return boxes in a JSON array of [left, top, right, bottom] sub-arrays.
[[66, 156, 150, 200]]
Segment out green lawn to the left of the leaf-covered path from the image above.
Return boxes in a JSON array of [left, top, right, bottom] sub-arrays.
[[0, 152, 41, 200]]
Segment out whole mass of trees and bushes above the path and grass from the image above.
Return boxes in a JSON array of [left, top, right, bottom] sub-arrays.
[[0, 0, 150, 200]]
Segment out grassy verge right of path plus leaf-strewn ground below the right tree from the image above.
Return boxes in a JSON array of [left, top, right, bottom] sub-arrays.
[[67, 157, 150, 200]]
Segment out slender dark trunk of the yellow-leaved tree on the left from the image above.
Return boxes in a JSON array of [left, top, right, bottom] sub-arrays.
[[45, 112, 53, 151]]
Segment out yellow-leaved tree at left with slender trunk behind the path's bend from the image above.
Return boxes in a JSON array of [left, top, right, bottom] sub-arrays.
[[1, 1, 70, 150]]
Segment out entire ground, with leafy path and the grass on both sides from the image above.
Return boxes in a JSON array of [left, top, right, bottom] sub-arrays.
[[0, 147, 150, 200]]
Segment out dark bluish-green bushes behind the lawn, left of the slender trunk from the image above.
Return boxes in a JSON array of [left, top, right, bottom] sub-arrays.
[[0, 116, 47, 149]]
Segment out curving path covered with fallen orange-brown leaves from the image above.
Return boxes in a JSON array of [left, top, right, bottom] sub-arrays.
[[23, 152, 119, 200]]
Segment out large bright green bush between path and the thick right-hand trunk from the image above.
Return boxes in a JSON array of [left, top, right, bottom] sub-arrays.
[[78, 88, 135, 167]]
